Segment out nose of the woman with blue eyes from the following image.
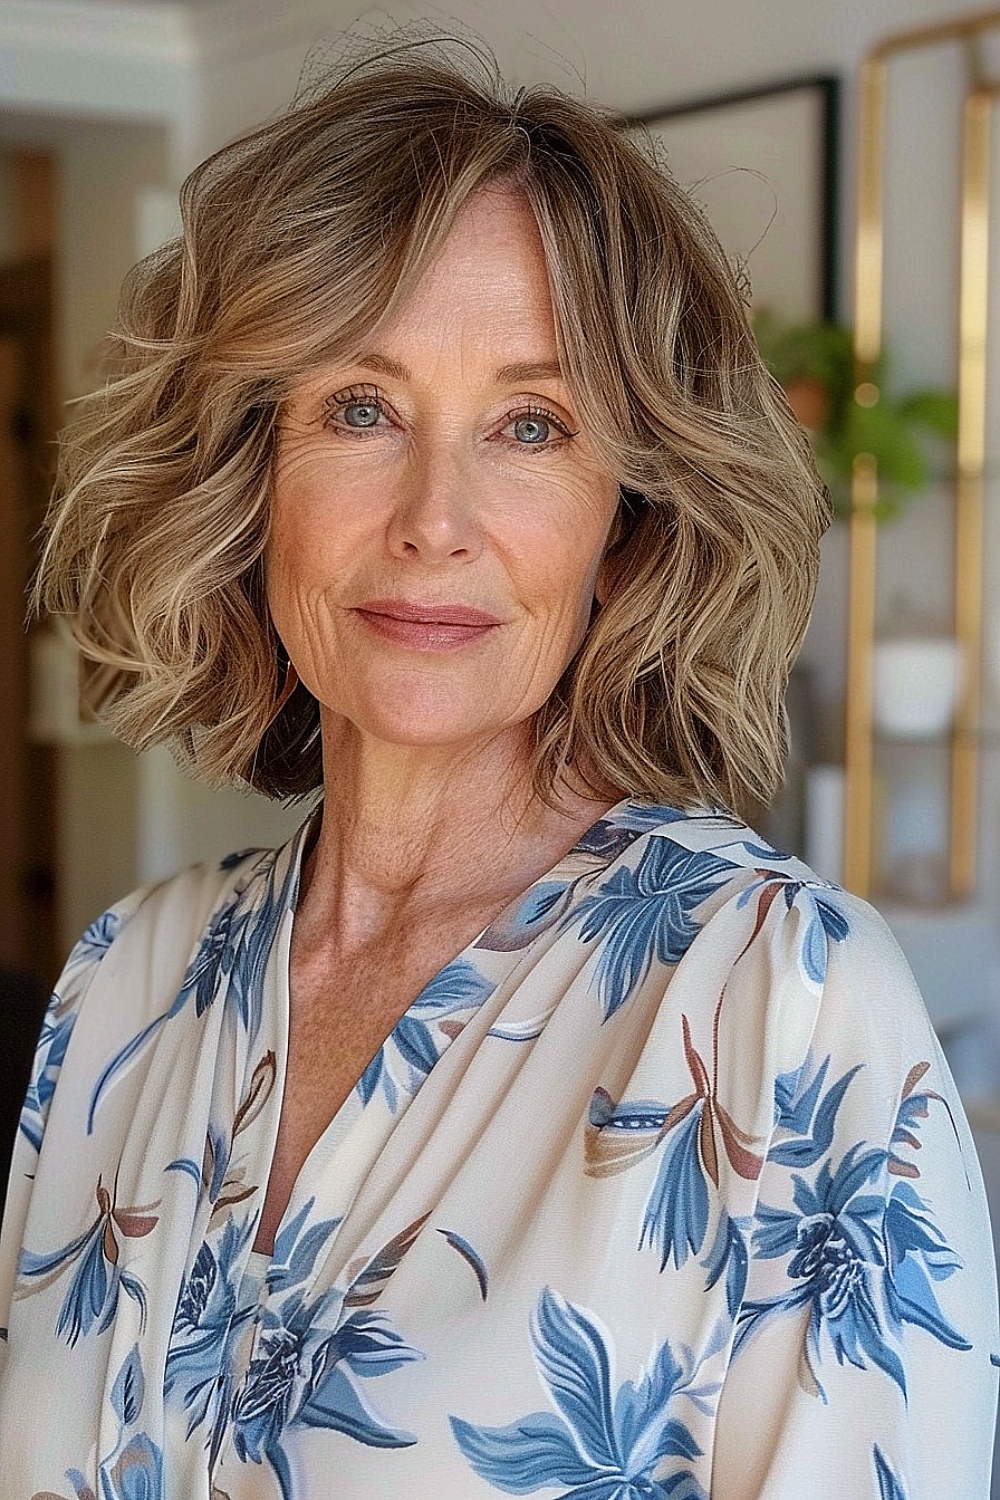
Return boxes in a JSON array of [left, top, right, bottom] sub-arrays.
[[387, 443, 483, 563]]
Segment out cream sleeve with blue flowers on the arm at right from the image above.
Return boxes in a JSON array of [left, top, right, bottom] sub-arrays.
[[711, 893, 997, 1500]]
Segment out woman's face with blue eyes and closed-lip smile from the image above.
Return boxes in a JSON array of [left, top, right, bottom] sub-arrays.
[[267, 191, 618, 762]]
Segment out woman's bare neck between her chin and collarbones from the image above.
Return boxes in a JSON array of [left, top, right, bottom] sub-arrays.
[[297, 719, 618, 951]]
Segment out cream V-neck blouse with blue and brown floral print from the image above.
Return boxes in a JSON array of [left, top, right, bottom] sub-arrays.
[[0, 801, 999, 1500]]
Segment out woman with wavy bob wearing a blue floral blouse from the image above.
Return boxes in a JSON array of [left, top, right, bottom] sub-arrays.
[[0, 47, 997, 1500]]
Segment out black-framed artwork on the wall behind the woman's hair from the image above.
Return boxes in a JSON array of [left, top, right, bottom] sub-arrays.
[[630, 74, 840, 323]]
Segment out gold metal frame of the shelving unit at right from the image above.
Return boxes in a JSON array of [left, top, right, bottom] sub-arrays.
[[844, 9, 1000, 900]]
